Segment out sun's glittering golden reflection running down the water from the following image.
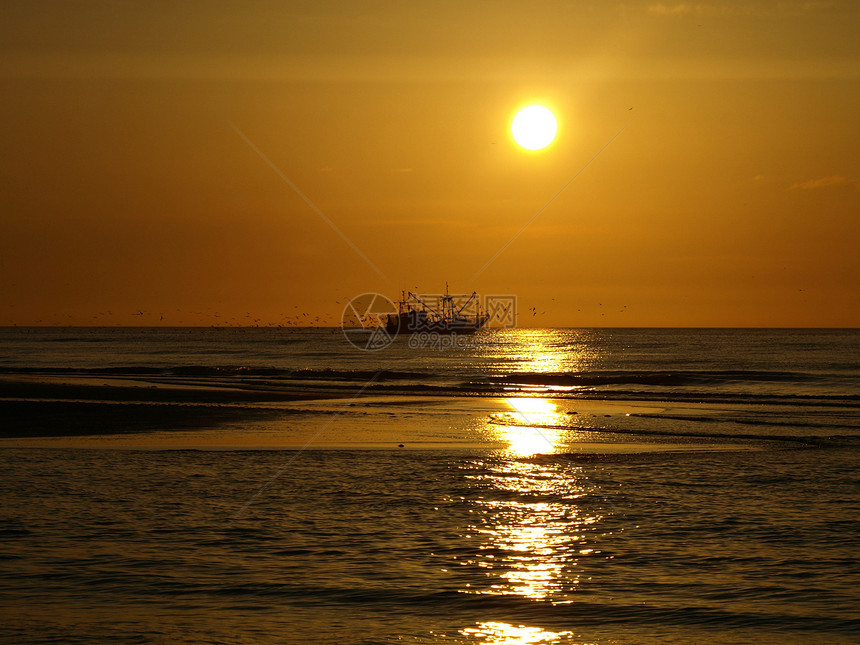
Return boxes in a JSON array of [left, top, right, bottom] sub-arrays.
[[461, 330, 602, 645]]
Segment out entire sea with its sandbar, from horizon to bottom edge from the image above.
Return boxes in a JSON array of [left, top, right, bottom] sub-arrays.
[[0, 328, 860, 645]]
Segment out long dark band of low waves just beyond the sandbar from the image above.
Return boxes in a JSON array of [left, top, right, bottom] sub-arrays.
[[0, 364, 860, 406]]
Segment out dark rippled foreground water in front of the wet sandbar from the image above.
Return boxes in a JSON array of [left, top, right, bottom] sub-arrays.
[[0, 449, 860, 643]]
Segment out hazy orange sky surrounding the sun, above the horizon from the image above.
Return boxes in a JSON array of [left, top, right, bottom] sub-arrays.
[[0, 0, 860, 327]]
